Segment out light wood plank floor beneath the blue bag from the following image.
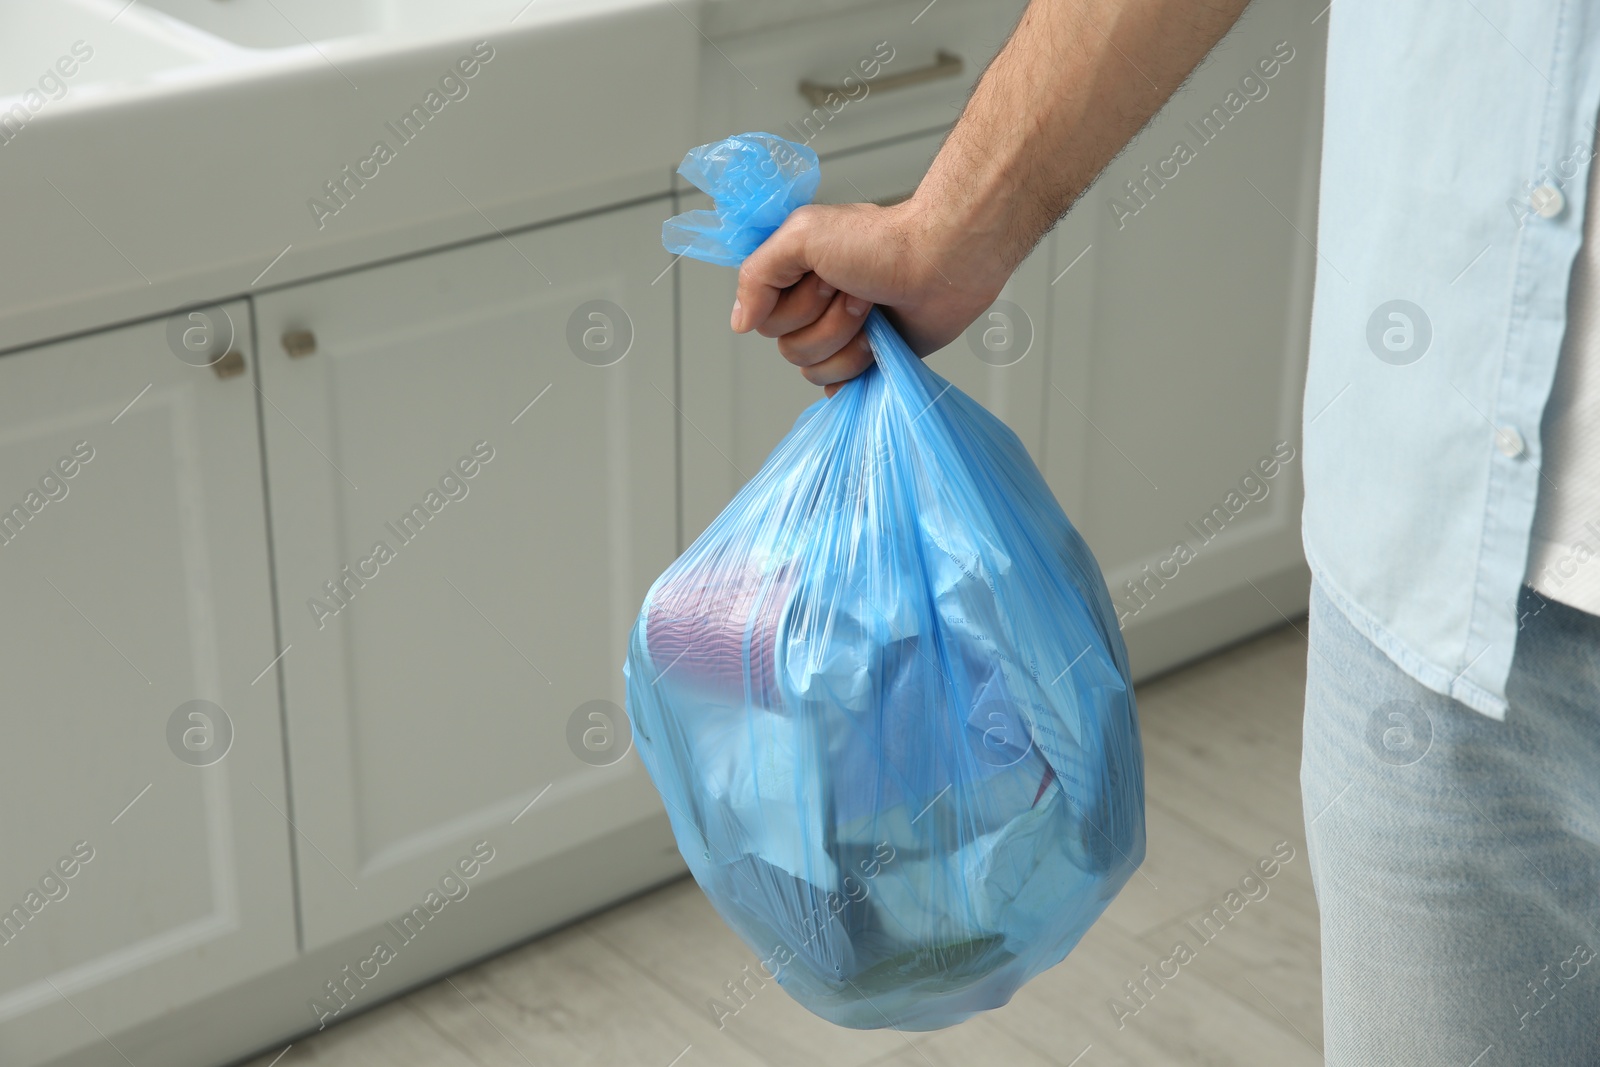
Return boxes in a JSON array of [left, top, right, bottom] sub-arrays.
[[251, 621, 1322, 1067]]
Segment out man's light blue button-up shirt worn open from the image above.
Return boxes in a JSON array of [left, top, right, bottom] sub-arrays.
[[1304, 0, 1600, 718]]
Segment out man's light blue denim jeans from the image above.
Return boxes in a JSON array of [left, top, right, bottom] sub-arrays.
[[1301, 585, 1600, 1067]]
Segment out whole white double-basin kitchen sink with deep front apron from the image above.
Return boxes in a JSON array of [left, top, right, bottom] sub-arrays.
[[0, 0, 702, 356]]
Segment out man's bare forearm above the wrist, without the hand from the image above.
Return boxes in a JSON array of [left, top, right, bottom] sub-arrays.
[[915, 0, 1248, 280]]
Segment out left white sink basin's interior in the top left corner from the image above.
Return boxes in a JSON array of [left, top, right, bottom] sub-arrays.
[[0, 0, 216, 103]]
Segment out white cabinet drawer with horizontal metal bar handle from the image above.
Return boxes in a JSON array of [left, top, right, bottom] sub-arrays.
[[699, 0, 1024, 152]]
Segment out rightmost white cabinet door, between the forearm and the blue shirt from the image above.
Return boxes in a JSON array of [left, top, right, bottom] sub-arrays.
[[1045, 0, 1326, 673]]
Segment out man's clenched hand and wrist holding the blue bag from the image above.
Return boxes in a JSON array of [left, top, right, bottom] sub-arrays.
[[731, 197, 1005, 397]]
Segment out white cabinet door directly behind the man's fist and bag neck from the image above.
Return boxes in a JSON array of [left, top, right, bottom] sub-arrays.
[[675, 134, 1051, 541]]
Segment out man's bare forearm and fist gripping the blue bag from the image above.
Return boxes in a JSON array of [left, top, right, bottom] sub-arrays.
[[731, 0, 1248, 397]]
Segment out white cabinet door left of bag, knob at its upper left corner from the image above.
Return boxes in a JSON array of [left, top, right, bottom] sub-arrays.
[[258, 198, 677, 949]]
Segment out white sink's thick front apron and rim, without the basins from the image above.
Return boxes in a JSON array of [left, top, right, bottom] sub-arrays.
[[0, 0, 704, 350]]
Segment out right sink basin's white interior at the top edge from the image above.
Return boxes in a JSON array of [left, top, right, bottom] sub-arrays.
[[138, 0, 531, 50]]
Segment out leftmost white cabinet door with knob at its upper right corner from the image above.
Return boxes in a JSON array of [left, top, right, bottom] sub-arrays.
[[0, 302, 294, 1067]]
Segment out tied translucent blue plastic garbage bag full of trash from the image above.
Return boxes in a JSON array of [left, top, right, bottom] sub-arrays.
[[622, 133, 1144, 1030]]
